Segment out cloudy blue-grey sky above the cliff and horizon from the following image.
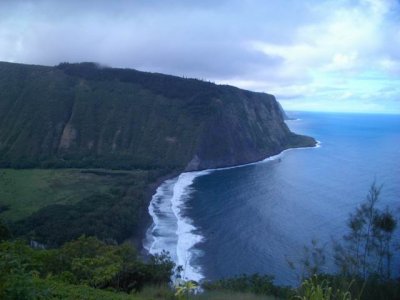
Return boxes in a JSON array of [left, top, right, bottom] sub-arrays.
[[0, 0, 400, 113]]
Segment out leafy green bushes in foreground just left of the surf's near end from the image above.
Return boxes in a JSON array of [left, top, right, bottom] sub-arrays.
[[56, 237, 174, 292]]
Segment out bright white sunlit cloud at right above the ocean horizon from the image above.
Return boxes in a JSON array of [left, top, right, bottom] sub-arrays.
[[245, 1, 400, 112]]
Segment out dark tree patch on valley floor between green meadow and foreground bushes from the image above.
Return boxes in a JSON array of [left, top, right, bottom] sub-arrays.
[[15, 194, 140, 247]]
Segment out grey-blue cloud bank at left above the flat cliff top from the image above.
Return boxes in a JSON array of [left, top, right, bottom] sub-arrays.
[[0, 1, 296, 79]]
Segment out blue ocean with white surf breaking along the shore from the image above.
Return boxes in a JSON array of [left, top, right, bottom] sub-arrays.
[[144, 112, 400, 285]]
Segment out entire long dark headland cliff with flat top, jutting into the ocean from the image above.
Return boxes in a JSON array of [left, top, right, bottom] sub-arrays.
[[0, 63, 315, 170]]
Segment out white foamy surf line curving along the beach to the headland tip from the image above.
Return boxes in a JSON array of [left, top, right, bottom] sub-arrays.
[[143, 141, 321, 282]]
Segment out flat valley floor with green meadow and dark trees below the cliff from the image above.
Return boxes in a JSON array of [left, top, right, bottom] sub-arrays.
[[0, 169, 163, 246]]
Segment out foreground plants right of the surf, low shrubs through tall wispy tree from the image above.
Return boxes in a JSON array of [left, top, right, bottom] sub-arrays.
[[204, 182, 400, 300]]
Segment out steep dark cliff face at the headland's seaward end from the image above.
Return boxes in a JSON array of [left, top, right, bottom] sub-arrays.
[[186, 87, 315, 170]]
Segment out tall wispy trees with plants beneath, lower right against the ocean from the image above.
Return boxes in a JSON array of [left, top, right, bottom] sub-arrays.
[[290, 182, 400, 300]]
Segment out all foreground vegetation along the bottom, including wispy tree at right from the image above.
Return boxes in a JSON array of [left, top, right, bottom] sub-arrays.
[[0, 180, 400, 300]]
